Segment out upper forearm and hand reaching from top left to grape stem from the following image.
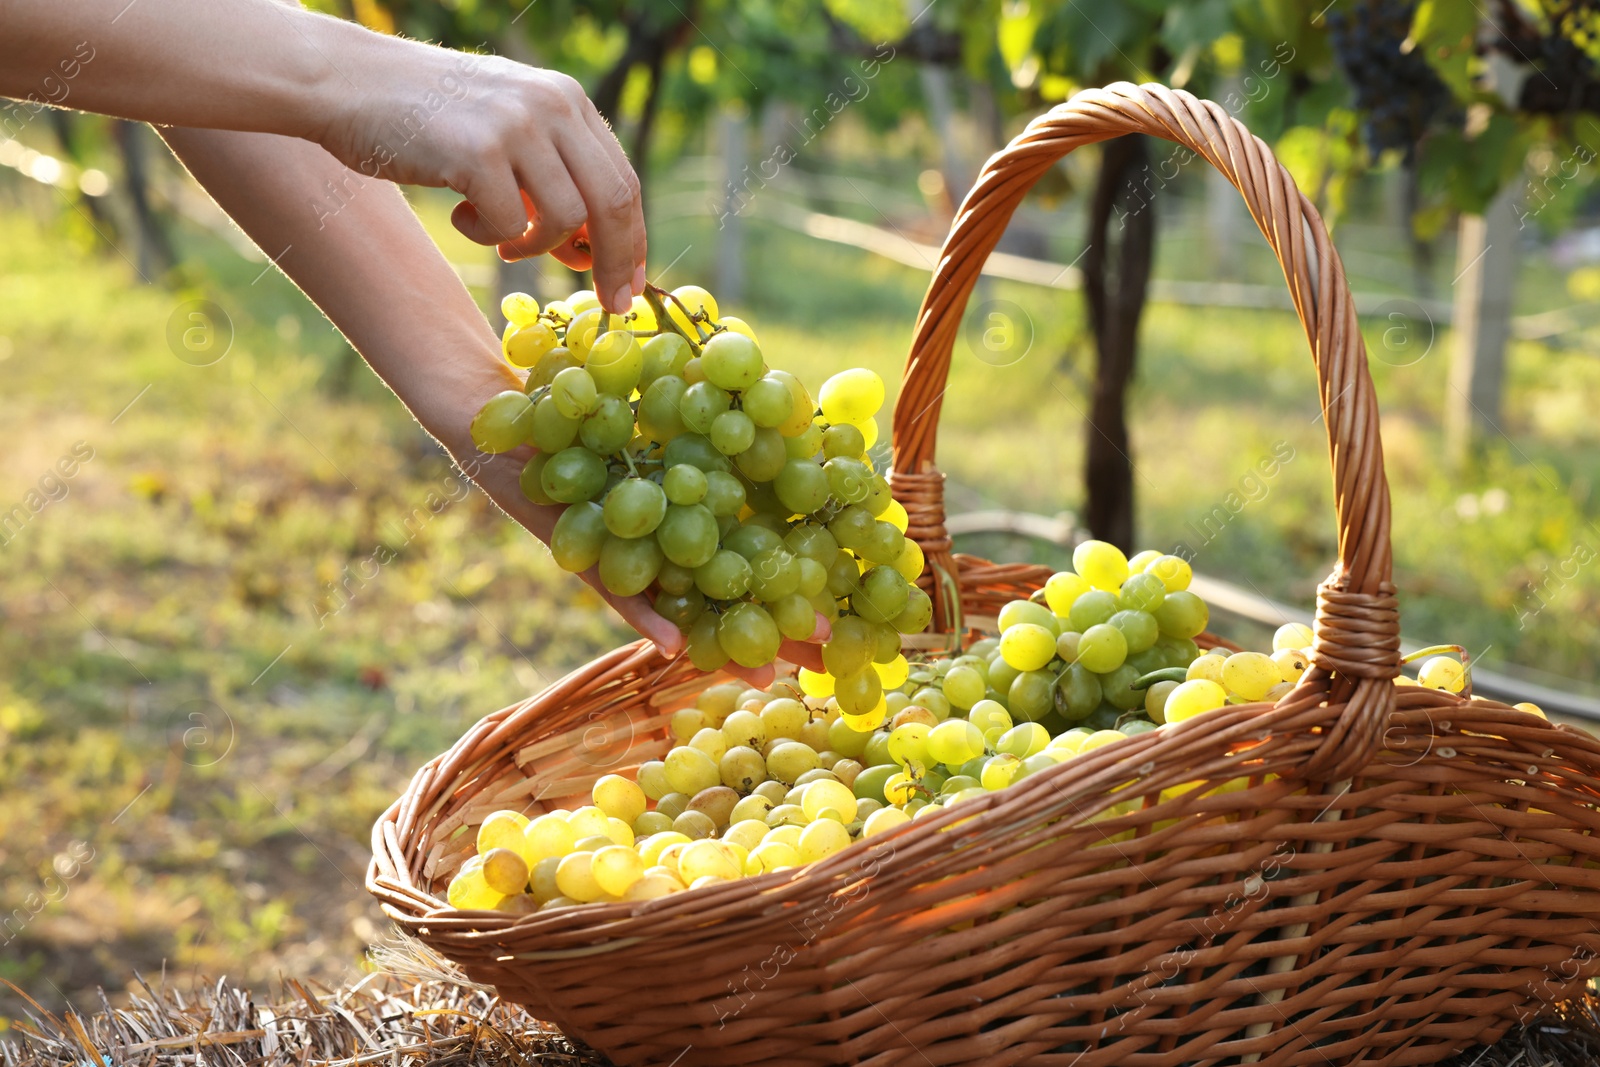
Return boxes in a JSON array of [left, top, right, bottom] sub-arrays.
[[0, 0, 646, 312]]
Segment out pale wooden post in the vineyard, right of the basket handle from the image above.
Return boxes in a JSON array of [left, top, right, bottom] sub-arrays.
[[1445, 182, 1522, 469]]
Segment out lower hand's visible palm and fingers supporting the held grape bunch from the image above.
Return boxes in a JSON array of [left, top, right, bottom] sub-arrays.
[[461, 446, 832, 689]]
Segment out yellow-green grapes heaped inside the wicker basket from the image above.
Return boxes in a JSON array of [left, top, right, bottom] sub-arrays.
[[448, 542, 1542, 913]]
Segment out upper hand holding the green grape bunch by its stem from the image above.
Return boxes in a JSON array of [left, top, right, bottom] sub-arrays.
[[318, 42, 646, 314]]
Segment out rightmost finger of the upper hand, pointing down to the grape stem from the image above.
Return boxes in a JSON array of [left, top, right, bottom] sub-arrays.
[[557, 130, 645, 315]]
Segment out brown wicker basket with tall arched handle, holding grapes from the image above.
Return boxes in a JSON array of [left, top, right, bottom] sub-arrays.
[[368, 85, 1600, 1067]]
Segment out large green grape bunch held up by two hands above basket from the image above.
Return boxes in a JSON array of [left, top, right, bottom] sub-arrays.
[[472, 286, 933, 668]]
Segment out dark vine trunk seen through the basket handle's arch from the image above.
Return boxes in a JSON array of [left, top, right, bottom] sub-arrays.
[[1083, 134, 1155, 550]]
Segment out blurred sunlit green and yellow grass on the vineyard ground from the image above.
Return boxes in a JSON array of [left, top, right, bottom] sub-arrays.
[[0, 171, 1600, 1025]]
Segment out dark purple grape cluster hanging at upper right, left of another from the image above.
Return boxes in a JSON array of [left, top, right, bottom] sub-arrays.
[[1325, 0, 1461, 165]]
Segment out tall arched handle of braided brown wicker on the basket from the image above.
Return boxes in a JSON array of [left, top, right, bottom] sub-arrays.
[[891, 82, 1400, 781]]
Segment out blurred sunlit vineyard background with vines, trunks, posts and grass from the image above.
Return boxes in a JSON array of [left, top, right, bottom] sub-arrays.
[[0, 0, 1600, 1029]]
